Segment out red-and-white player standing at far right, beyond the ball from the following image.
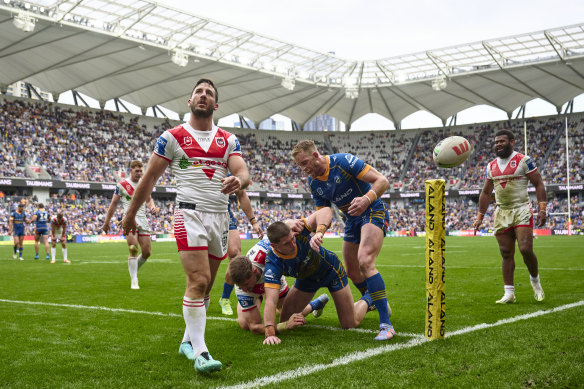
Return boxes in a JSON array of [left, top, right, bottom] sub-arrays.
[[473, 130, 547, 304]]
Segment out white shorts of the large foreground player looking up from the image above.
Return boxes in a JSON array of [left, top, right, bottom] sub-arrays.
[[174, 207, 229, 261]]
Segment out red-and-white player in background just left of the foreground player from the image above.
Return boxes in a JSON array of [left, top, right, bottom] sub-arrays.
[[101, 160, 156, 289]]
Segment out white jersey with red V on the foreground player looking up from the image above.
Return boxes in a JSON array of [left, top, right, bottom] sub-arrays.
[[154, 123, 241, 212]]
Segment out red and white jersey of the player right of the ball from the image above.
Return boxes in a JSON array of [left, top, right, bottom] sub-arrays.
[[487, 151, 537, 209]]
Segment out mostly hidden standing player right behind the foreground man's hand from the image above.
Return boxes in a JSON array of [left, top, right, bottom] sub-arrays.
[[219, 190, 264, 316]]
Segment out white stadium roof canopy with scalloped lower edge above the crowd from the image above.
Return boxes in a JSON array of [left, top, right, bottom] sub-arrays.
[[0, 0, 584, 125]]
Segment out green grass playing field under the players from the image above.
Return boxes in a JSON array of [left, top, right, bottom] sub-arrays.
[[0, 236, 584, 388]]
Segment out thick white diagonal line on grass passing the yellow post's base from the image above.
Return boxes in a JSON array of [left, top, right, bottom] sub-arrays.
[[220, 300, 584, 389]]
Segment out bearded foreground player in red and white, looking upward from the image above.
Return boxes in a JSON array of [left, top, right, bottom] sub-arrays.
[[123, 79, 249, 373]]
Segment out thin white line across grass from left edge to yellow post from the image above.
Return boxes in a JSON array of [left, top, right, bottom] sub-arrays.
[[0, 299, 423, 338]]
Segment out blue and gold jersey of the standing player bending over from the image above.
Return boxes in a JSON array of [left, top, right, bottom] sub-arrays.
[[308, 154, 383, 212]]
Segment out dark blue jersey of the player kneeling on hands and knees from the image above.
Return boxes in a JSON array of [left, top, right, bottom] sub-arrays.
[[264, 227, 344, 289]]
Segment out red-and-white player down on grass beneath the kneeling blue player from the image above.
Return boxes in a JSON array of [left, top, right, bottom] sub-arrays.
[[229, 239, 329, 334]]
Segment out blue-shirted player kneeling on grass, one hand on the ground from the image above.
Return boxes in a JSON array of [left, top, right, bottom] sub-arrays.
[[264, 207, 373, 344]]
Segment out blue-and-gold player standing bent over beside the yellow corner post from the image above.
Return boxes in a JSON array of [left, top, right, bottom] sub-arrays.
[[292, 140, 395, 340]]
